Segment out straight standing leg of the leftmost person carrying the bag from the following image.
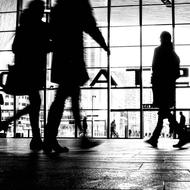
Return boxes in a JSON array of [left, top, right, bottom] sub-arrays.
[[29, 91, 42, 150]]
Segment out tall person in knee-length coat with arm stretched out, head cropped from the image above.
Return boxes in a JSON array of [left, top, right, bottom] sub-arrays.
[[44, 0, 109, 152]]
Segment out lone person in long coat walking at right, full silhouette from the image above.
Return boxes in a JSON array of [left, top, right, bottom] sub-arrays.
[[146, 31, 187, 147]]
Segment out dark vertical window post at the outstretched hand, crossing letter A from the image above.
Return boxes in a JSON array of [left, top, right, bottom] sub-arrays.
[[107, 0, 111, 139]]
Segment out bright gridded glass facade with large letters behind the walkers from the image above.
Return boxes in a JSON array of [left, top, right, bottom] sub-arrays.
[[0, 0, 190, 138]]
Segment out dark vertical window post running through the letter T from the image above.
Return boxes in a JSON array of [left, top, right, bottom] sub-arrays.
[[139, 0, 144, 139]]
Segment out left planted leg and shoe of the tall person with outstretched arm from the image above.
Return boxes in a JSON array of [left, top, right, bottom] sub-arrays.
[[44, 85, 68, 153]]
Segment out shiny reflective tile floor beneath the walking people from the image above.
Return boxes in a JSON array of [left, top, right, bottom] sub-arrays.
[[0, 138, 190, 190]]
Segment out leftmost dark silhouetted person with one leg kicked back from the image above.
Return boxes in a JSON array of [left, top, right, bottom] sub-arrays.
[[0, 0, 50, 151]]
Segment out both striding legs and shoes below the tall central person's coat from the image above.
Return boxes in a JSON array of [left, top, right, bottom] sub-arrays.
[[44, 85, 99, 153]]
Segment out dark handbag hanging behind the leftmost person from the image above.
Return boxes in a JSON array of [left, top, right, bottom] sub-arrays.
[[0, 65, 30, 96]]
